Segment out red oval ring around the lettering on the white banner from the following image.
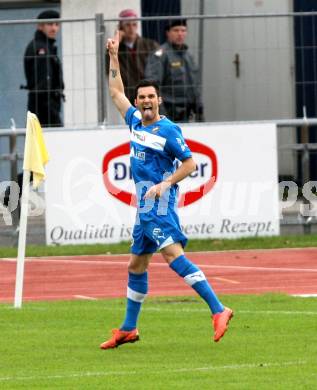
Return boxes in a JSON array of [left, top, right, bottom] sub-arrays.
[[102, 139, 218, 207]]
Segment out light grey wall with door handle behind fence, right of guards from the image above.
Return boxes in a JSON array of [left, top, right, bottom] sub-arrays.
[[182, 0, 296, 175]]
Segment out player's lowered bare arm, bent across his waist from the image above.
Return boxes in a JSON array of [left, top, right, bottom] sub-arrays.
[[144, 157, 196, 199]]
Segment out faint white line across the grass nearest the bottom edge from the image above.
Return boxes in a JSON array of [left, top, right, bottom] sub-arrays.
[[0, 360, 307, 382]]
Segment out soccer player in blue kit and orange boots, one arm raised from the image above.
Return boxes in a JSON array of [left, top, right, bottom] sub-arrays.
[[100, 31, 233, 349]]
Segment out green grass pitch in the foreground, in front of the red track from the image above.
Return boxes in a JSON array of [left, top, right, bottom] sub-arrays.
[[0, 294, 317, 390]]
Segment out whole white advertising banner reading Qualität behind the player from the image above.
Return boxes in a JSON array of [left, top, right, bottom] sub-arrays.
[[45, 124, 279, 244]]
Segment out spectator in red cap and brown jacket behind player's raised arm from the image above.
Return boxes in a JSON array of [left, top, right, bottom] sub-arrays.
[[106, 9, 159, 104]]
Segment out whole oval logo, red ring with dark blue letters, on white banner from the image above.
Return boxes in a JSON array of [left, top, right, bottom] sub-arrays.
[[102, 139, 218, 207]]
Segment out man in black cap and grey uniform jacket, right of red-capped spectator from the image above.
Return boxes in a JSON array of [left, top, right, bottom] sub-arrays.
[[145, 19, 204, 122]]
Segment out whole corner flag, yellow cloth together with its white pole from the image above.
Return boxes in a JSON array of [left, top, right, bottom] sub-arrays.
[[14, 112, 49, 308]]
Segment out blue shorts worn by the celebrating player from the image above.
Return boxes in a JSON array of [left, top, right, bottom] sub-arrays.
[[131, 209, 187, 255]]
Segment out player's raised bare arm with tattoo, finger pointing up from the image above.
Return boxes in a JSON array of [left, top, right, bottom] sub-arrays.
[[107, 31, 131, 118]]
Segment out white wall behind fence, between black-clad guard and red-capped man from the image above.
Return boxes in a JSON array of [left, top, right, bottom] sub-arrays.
[[61, 0, 140, 126]]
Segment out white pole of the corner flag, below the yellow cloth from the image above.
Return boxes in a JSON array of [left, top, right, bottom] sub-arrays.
[[14, 169, 31, 309]]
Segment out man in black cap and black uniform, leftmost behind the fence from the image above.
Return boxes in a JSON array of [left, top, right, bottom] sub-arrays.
[[24, 10, 64, 127]]
